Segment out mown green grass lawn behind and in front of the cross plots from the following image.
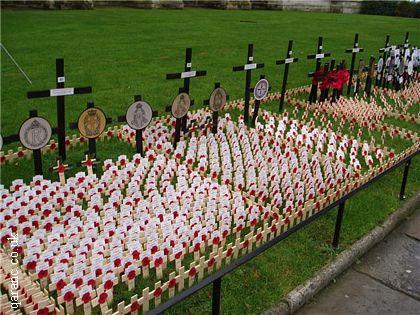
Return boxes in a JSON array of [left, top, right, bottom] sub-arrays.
[[1, 9, 420, 314]]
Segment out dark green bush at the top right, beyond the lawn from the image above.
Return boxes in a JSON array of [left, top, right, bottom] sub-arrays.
[[360, 1, 420, 18]]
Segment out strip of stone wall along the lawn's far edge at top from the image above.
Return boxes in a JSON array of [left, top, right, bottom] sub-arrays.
[[1, 0, 392, 13]]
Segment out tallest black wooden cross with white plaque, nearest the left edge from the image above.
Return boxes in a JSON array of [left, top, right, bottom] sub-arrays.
[[27, 58, 92, 161]]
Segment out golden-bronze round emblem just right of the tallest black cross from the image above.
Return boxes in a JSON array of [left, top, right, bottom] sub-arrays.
[[77, 107, 106, 139]]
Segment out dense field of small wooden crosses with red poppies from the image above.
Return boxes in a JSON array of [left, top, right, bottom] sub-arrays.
[[0, 34, 420, 314]]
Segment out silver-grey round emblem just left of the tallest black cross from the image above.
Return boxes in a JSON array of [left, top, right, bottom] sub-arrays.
[[19, 117, 52, 150]]
